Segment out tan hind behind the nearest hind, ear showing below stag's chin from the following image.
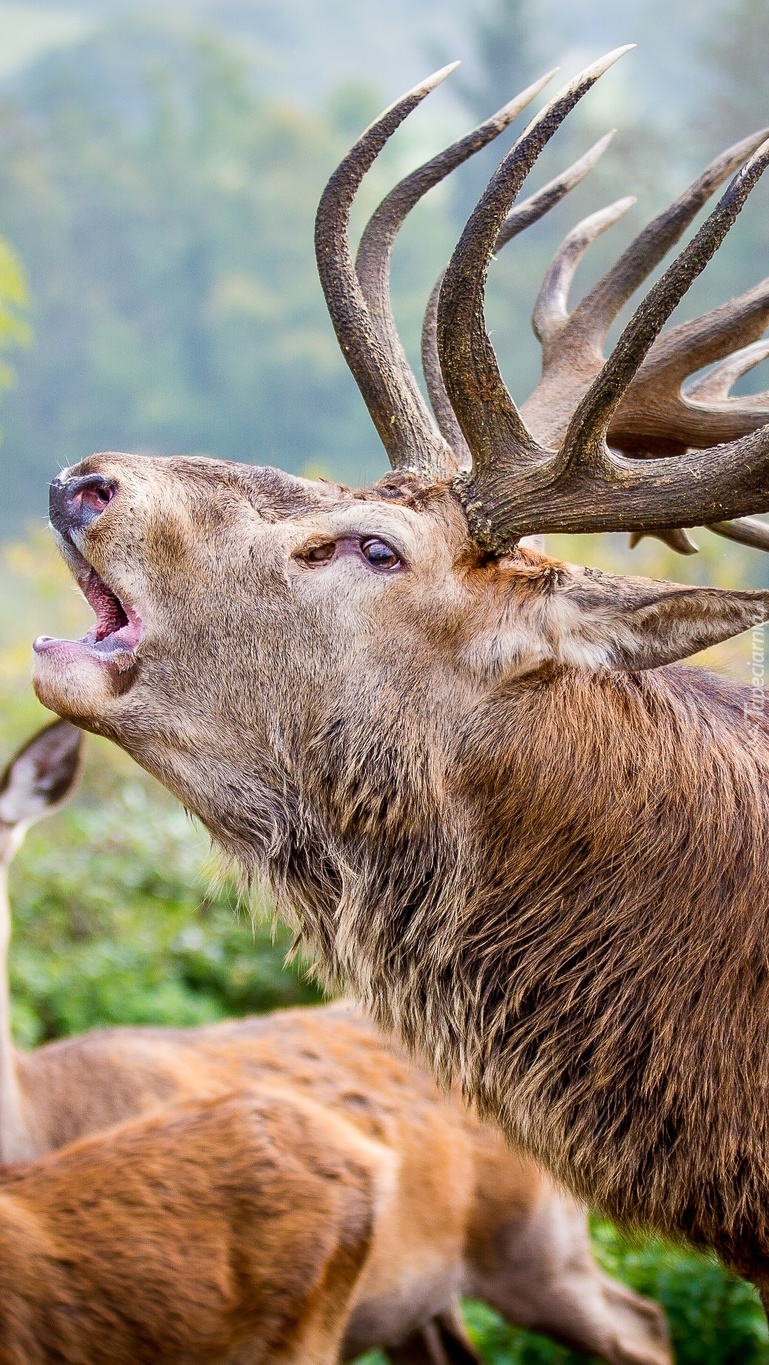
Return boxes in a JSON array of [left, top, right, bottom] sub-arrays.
[[0, 721, 671, 1365]]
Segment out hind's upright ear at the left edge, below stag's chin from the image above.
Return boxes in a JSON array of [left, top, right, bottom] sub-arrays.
[[0, 721, 83, 824]]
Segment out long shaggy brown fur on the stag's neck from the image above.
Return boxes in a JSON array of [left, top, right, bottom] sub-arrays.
[[255, 667, 769, 1280]]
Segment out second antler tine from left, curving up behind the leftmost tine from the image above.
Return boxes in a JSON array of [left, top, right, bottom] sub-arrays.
[[355, 71, 555, 475]]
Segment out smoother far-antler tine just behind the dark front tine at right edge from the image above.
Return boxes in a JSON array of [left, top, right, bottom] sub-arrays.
[[572, 128, 769, 348]]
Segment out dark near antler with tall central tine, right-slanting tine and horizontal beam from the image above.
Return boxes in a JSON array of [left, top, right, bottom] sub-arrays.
[[438, 64, 769, 553]]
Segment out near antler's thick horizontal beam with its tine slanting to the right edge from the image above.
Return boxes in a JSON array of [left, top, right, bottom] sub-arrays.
[[453, 134, 769, 543]]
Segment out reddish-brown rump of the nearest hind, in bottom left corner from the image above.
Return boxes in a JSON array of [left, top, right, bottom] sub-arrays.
[[0, 1095, 376, 1365]]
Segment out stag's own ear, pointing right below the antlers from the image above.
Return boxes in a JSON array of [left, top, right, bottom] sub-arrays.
[[552, 565, 769, 670]]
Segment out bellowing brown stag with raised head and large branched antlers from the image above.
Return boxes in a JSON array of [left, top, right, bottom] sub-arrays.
[[36, 53, 769, 1306]]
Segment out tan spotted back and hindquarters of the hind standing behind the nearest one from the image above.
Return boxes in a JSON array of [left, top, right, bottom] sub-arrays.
[[12, 1003, 671, 1365]]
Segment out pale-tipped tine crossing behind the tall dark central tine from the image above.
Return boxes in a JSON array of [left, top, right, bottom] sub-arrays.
[[422, 130, 615, 468]]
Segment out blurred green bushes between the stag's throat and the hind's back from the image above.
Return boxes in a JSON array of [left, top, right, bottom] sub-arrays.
[[11, 781, 318, 1046]]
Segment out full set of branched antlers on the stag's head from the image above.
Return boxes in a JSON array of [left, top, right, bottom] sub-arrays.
[[317, 48, 769, 553]]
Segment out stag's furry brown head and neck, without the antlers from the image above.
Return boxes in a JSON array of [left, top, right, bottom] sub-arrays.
[[36, 456, 769, 1284]]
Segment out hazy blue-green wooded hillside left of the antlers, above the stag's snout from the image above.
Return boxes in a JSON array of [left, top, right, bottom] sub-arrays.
[[0, 26, 420, 527]]
